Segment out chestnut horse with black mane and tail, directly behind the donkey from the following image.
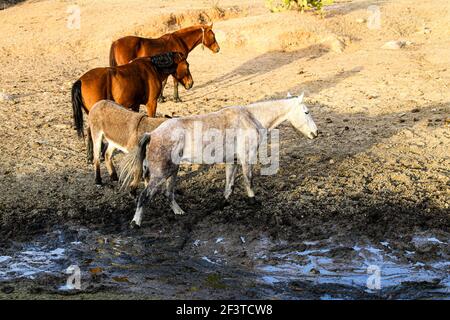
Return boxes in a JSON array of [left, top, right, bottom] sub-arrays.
[[72, 52, 194, 161]]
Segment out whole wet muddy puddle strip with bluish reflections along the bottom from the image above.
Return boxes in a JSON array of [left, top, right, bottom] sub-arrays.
[[0, 226, 450, 299]]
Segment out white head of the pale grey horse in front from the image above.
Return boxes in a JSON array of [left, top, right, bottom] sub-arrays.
[[285, 93, 319, 139]]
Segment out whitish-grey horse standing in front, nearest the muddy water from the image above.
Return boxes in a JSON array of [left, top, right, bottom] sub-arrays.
[[120, 94, 318, 227]]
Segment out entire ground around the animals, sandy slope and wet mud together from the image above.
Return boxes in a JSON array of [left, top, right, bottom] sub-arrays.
[[0, 0, 450, 299]]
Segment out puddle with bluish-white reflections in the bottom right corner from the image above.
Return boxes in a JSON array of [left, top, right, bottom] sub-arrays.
[[258, 236, 450, 299]]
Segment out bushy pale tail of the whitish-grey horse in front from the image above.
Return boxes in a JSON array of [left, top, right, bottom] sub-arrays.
[[119, 133, 151, 189]]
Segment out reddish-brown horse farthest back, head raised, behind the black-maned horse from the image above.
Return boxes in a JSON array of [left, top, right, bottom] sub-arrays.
[[109, 24, 220, 102]]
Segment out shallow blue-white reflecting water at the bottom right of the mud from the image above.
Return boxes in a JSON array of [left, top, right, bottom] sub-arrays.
[[258, 238, 450, 299]]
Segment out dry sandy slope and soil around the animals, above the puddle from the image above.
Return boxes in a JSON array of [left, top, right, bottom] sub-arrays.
[[0, 0, 450, 297]]
